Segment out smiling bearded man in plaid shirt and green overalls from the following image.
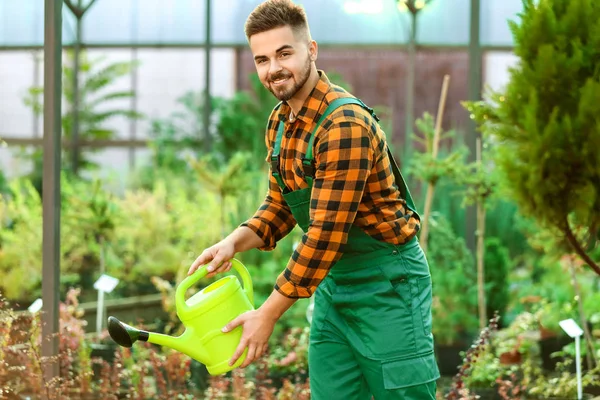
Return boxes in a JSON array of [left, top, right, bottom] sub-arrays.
[[189, 0, 439, 400]]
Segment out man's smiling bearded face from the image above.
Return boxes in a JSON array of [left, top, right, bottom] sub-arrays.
[[250, 26, 316, 101]]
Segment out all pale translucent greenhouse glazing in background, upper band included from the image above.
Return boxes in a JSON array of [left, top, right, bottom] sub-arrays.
[[0, 0, 522, 180]]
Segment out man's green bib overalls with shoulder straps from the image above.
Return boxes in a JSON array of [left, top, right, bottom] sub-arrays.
[[271, 98, 439, 400]]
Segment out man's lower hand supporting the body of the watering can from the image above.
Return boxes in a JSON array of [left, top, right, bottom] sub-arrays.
[[222, 308, 276, 368]]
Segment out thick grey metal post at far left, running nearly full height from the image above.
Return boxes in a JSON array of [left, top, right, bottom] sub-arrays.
[[42, 0, 62, 390]]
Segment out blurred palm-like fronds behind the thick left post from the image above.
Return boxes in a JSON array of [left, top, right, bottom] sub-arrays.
[[22, 51, 142, 184]]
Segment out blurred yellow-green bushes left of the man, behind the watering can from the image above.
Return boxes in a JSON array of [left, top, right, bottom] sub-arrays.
[[0, 176, 220, 301]]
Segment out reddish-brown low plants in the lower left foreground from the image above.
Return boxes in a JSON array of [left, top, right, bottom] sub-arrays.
[[0, 290, 310, 400]]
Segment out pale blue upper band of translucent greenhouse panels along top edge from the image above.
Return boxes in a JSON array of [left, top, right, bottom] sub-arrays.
[[0, 0, 522, 48]]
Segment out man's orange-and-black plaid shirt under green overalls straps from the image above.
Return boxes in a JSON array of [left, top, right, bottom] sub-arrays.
[[242, 71, 419, 298]]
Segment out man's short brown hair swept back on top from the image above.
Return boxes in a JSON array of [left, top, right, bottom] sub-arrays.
[[244, 0, 310, 40]]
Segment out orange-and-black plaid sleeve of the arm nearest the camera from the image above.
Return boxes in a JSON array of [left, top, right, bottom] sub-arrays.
[[275, 113, 374, 298]]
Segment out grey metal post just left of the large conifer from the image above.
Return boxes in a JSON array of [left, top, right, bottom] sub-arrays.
[[465, 0, 482, 253]]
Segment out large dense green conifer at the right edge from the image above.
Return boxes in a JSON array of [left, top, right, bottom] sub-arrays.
[[466, 0, 600, 274]]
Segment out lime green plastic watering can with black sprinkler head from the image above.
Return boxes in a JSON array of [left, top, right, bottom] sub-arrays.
[[108, 258, 254, 375]]
